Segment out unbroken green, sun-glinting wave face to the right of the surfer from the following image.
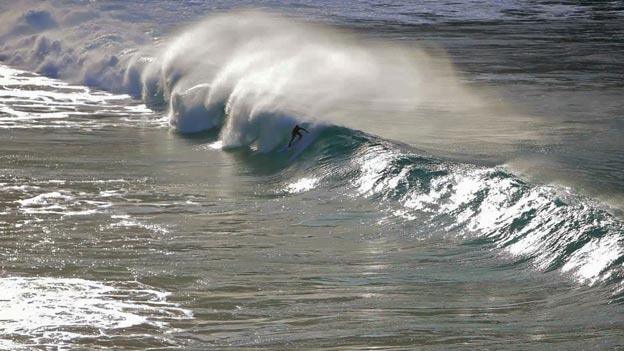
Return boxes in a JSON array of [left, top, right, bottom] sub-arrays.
[[271, 127, 624, 294]]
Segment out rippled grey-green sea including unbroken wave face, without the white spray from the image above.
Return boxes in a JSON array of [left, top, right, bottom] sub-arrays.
[[0, 1, 624, 350]]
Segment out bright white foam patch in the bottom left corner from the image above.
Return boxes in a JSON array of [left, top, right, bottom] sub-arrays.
[[0, 277, 192, 350]]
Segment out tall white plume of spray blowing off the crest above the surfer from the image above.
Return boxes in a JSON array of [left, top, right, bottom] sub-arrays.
[[156, 12, 488, 148]]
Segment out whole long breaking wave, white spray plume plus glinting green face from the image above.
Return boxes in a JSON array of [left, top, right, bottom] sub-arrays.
[[0, 2, 624, 291]]
